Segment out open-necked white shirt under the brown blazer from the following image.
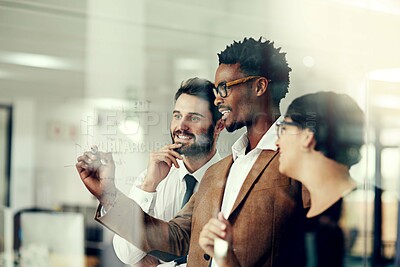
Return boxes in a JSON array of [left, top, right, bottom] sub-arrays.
[[211, 123, 277, 267]]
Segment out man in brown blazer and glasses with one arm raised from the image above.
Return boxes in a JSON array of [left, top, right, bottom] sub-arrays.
[[79, 38, 305, 267]]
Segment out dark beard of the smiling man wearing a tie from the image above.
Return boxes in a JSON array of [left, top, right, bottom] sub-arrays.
[[171, 126, 214, 157]]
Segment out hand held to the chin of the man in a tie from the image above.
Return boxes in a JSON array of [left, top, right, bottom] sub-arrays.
[[141, 144, 183, 192]]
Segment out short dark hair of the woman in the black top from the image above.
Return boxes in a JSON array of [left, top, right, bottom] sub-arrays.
[[285, 92, 364, 167]]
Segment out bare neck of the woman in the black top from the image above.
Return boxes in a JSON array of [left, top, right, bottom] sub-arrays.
[[296, 152, 357, 218]]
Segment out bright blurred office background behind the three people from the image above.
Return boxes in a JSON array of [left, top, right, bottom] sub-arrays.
[[0, 0, 400, 267]]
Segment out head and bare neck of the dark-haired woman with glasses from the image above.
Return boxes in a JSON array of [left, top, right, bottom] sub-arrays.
[[276, 92, 364, 217]]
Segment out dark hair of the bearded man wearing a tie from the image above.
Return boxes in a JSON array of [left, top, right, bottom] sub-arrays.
[[175, 77, 222, 125]]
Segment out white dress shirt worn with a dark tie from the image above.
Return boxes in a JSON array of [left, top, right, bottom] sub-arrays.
[[113, 152, 221, 266]]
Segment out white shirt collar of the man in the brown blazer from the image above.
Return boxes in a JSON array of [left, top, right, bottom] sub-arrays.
[[232, 117, 282, 160]]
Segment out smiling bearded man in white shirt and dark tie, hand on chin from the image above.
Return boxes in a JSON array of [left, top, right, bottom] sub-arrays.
[[113, 78, 223, 267]]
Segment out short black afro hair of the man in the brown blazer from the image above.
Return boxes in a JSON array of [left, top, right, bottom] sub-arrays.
[[218, 37, 292, 108]]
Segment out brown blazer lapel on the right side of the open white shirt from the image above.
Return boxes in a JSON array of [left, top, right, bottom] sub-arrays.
[[229, 150, 278, 219]]
